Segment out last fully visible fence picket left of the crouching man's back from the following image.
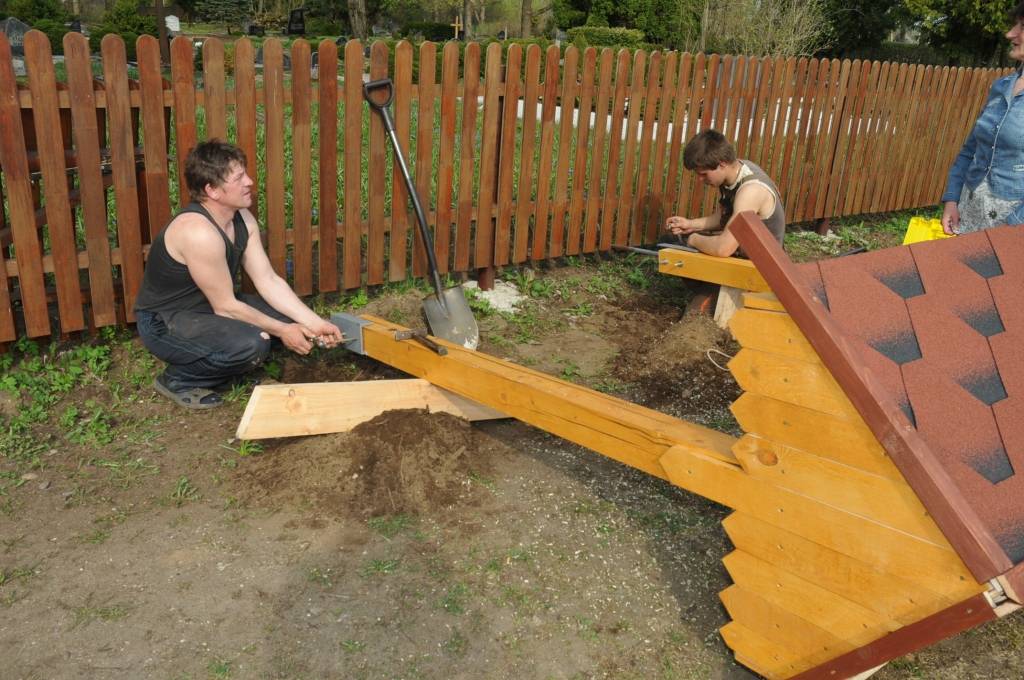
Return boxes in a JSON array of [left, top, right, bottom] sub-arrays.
[[102, 33, 142, 322]]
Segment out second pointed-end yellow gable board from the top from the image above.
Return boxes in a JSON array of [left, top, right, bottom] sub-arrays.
[[729, 348, 857, 419]]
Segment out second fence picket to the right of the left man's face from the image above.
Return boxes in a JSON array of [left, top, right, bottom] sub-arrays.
[[290, 39, 313, 295]]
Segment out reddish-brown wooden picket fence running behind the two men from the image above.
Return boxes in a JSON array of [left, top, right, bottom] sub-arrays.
[[0, 32, 1001, 342]]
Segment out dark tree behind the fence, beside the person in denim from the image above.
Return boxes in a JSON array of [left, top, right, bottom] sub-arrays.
[[903, 0, 1010, 65]]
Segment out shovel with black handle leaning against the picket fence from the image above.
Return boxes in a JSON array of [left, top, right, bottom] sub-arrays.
[[362, 78, 480, 349]]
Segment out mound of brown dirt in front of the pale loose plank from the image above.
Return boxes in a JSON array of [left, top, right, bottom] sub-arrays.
[[236, 410, 502, 517]]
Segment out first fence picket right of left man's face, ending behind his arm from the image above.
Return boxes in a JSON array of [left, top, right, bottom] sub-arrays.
[[263, 38, 288, 279]]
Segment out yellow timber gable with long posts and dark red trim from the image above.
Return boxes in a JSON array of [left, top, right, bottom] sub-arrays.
[[256, 214, 1024, 680]]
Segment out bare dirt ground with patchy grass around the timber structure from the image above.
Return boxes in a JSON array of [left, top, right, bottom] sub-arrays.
[[0, 251, 1024, 679]]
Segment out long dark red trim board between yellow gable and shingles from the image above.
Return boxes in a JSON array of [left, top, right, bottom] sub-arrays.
[[729, 212, 1013, 577]]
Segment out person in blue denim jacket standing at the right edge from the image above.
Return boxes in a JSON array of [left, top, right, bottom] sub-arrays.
[[942, 2, 1024, 233]]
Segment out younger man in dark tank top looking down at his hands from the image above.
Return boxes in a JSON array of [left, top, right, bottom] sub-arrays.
[[666, 130, 785, 257]]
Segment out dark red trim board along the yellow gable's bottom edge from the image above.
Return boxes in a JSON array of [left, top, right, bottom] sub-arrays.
[[786, 593, 996, 680]]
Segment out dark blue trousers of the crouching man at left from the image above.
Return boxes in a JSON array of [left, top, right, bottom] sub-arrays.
[[135, 294, 292, 391]]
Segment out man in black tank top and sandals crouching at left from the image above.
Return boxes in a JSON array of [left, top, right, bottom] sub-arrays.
[[135, 139, 343, 409]]
